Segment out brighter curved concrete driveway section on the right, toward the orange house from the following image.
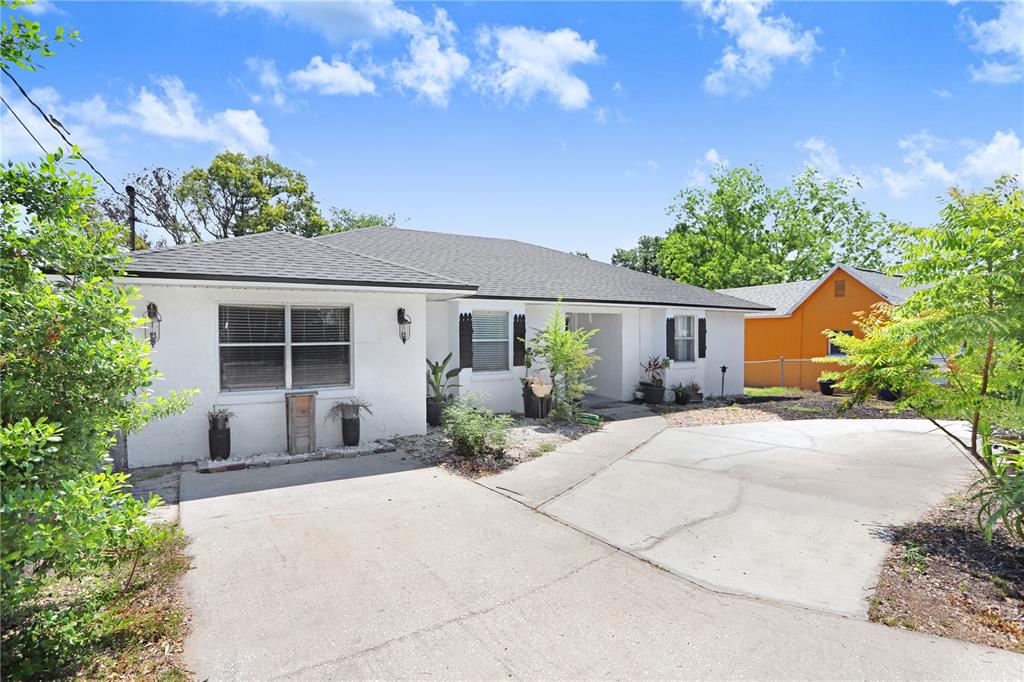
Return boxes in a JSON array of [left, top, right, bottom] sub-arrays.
[[507, 420, 972, 617]]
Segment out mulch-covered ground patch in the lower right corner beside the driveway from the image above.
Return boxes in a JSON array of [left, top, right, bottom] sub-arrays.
[[868, 493, 1024, 653]]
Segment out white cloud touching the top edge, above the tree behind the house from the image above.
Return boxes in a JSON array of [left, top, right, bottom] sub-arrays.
[[701, 0, 817, 95]]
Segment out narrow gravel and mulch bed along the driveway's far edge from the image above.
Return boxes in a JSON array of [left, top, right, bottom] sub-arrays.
[[658, 391, 918, 426]]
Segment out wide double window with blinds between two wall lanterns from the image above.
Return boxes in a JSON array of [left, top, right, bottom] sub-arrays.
[[219, 305, 352, 391]]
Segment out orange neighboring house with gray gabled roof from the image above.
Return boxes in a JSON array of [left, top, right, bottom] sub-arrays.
[[720, 264, 911, 390]]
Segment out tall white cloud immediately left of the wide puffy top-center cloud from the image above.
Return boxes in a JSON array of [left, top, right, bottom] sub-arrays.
[[394, 9, 469, 106]]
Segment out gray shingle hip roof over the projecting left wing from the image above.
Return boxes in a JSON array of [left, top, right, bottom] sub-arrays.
[[125, 232, 475, 291]]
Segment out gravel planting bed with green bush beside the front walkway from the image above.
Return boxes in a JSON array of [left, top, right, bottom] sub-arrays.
[[390, 411, 596, 478]]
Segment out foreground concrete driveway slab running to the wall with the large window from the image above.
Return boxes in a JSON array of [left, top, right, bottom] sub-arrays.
[[180, 418, 1022, 680]]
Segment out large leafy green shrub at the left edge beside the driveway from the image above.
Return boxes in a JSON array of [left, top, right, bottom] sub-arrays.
[[0, 153, 192, 624]]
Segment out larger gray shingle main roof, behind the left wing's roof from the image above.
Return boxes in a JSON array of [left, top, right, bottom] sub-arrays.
[[315, 227, 765, 310]]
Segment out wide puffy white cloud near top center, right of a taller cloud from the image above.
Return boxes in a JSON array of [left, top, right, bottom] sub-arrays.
[[476, 27, 601, 110]]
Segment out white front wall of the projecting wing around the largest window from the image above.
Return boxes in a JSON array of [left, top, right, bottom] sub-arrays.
[[128, 284, 429, 467]]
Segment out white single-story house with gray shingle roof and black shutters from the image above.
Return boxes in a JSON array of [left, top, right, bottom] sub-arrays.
[[122, 227, 765, 467]]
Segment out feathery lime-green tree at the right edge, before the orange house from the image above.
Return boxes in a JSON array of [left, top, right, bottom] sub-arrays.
[[822, 177, 1024, 539]]
